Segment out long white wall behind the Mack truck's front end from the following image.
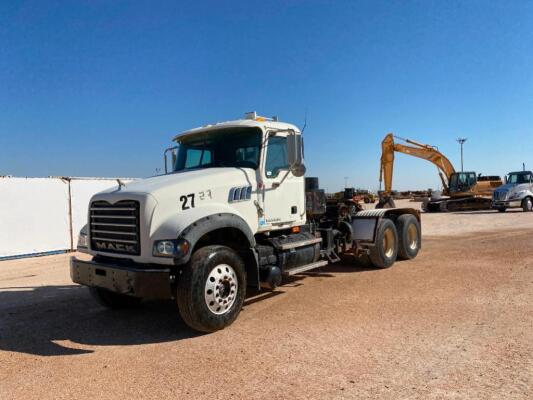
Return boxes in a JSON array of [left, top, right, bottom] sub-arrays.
[[0, 177, 130, 259]]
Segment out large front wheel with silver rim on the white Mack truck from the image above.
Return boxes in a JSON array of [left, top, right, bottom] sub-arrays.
[[177, 245, 246, 332]]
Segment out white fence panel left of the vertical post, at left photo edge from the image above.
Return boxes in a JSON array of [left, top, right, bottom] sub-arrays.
[[0, 178, 70, 257]]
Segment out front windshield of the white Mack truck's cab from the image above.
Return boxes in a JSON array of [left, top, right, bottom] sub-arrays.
[[174, 128, 261, 172]]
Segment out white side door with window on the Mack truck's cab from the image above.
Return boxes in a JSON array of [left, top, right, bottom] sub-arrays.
[[260, 132, 305, 228]]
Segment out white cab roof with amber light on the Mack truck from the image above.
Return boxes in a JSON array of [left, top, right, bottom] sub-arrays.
[[172, 112, 300, 141]]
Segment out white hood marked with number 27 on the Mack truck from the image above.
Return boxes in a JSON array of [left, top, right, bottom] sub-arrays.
[[89, 167, 259, 264]]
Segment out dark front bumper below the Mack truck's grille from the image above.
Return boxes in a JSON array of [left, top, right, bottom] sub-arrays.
[[70, 257, 172, 300]]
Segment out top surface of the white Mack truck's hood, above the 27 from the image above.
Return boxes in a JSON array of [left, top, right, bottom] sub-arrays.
[[99, 168, 255, 200]]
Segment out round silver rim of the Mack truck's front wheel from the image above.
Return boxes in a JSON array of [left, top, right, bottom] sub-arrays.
[[204, 264, 239, 315]]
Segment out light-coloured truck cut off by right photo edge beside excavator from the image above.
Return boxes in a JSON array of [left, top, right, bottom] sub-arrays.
[[492, 171, 533, 212]]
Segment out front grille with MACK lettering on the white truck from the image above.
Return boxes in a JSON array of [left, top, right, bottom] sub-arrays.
[[89, 200, 141, 255]]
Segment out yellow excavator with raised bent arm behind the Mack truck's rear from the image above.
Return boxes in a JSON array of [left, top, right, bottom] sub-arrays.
[[376, 133, 503, 212]]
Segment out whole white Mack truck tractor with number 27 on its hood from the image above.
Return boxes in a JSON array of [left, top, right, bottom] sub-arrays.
[[70, 112, 421, 332]]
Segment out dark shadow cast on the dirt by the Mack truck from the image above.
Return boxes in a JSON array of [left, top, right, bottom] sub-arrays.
[[0, 262, 374, 356]]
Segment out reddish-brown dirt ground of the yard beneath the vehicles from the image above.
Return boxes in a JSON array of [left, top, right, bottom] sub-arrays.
[[0, 202, 533, 400]]
